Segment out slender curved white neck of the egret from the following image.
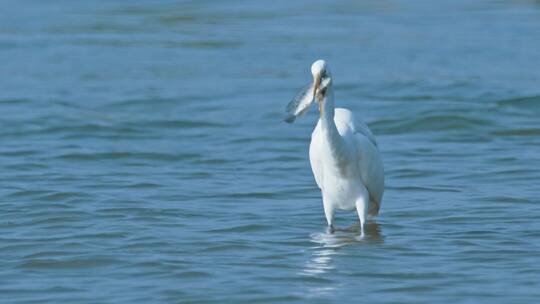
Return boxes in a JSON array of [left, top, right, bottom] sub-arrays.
[[320, 88, 348, 163]]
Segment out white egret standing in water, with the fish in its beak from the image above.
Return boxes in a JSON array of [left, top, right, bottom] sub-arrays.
[[285, 60, 384, 237]]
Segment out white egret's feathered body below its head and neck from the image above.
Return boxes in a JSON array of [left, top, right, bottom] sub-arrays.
[[309, 108, 384, 235]]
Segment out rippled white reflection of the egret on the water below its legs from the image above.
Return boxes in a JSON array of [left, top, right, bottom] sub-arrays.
[[301, 222, 384, 278]]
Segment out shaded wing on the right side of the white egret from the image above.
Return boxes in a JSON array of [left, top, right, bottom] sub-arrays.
[[355, 121, 384, 216]]
